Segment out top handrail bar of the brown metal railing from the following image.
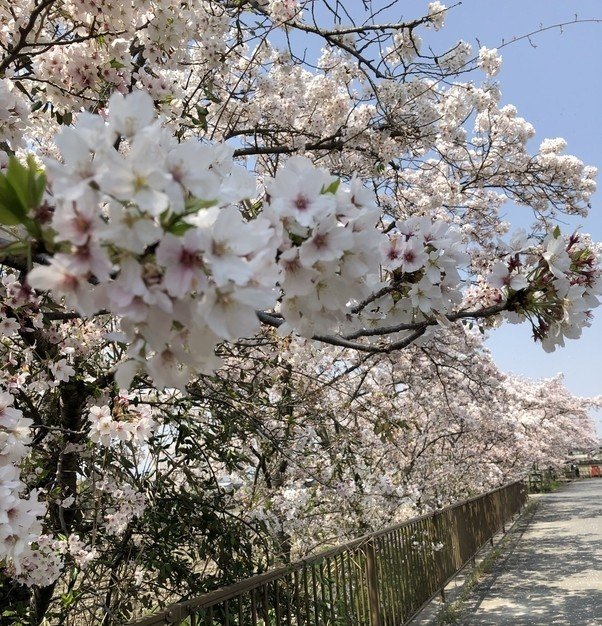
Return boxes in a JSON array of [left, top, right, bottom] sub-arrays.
[[128, 480, 523, 626]]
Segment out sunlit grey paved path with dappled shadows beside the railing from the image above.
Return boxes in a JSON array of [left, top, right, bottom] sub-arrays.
[[460, 479, 602, 626]]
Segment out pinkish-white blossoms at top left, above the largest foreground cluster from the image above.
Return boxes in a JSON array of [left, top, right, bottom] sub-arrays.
[[17, 0, 227, 112]]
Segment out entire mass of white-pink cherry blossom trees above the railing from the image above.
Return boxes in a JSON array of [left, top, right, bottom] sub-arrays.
[[0, 0, 601, 624]]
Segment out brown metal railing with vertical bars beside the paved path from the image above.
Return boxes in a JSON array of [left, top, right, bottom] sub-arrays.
[[131, 482, 527, 626]]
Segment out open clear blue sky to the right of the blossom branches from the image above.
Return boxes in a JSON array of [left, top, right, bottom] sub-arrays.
[[399, 0, 602, 428]]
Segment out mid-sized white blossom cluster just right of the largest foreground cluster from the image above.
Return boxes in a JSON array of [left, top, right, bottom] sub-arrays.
[[263, 157, 384, 337]]
